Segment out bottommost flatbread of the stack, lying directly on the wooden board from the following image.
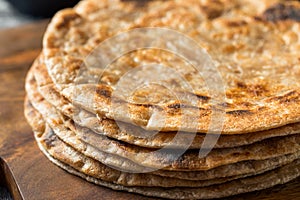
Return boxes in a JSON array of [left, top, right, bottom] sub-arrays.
[[25, 97, 300, 199]]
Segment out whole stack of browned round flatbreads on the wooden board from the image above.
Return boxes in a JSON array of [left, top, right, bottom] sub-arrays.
[[25, 0, 300, 199]]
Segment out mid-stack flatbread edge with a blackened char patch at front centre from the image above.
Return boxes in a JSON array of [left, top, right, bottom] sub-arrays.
[[26, 66, 300, 171]]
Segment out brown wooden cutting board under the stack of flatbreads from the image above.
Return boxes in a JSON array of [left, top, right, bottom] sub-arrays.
[[0, 21, 300, 200]]
